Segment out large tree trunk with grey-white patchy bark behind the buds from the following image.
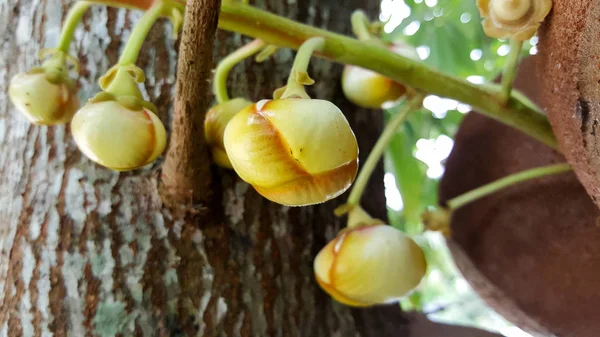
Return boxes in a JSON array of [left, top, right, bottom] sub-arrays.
[[0, 0, 506, 337]]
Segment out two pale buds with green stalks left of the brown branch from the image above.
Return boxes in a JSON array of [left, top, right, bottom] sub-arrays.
[[9, 1, 176, 171]]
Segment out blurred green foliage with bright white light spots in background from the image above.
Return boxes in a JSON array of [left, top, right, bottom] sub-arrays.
[[379, 0, 537, 337]]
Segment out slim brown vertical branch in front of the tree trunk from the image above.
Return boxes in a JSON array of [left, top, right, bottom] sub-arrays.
[[161, 0, 221, 206]]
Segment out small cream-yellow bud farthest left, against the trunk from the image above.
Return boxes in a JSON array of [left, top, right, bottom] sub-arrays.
[[8, 68, 79, 125]]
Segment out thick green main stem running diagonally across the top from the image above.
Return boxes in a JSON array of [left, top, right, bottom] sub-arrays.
[[92, 0, 557, 149]]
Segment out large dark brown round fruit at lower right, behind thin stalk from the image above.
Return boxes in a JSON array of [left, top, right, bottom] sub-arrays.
[[440, 58, 600, 337]]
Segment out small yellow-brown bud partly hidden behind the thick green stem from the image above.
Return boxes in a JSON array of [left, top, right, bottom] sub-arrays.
[[342, 44, 419, 109]]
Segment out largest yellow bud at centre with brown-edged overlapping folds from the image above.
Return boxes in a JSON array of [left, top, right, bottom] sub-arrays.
[[224, 98, 358, 206]]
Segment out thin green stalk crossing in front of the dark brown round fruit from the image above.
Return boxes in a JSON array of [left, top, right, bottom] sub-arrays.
[[447, 163, 571, 210]]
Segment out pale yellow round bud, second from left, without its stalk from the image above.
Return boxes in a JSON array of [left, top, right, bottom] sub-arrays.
[[71, 100, 167, 171]]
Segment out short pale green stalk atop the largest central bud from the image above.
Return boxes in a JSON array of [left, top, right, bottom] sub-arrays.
[[281, 37, 325, 98]]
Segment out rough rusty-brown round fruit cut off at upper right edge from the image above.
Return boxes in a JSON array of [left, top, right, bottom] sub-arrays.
[[539, 0, 600, 210]]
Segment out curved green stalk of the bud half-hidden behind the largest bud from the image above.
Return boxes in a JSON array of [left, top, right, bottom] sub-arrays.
[[213, 39, 266, 104]]
